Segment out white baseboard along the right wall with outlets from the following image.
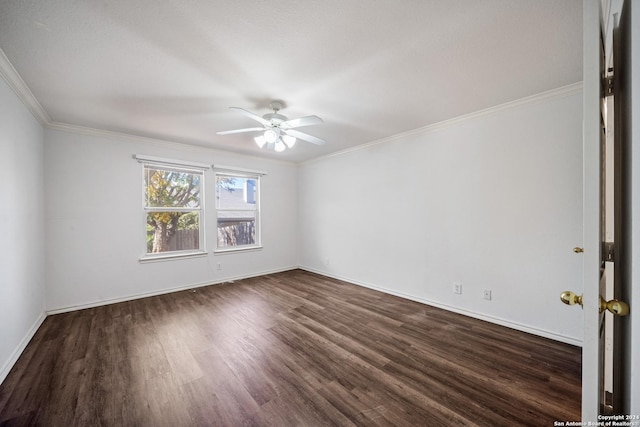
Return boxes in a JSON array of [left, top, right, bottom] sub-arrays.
[[298, 266, 582, 347]]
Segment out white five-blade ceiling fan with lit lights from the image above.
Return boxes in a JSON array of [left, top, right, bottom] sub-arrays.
[[217, 101, 326, 152]]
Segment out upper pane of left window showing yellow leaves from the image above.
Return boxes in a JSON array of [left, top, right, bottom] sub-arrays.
[[144, 166, 202, 208]]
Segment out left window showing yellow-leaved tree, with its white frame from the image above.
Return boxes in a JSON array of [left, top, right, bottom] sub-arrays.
[[136, 156, 208, 259]]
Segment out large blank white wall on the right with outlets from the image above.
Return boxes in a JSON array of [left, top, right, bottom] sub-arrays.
[[299, 86, 582, 344]]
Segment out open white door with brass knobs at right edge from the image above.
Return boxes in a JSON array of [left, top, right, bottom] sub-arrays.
[[576, 0, 629, 421]]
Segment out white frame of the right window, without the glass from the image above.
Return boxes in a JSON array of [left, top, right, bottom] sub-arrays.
[[213, 165, 266, 254]]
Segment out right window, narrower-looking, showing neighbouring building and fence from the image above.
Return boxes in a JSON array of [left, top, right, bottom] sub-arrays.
[[215, 166, 262, 251]]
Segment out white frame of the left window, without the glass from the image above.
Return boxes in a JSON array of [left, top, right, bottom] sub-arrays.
[[134, 155, 211, 262]]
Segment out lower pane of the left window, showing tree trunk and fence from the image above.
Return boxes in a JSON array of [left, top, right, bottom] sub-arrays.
[[147, 211, 200, 254]]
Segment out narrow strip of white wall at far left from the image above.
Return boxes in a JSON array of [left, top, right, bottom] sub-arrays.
[[0, 78, 44, 383]]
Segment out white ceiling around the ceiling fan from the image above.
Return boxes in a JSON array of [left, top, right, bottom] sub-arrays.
[[0, 0, 582, 162]]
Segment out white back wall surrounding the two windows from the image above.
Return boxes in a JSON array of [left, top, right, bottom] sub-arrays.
[[45, 129, 297, 312]]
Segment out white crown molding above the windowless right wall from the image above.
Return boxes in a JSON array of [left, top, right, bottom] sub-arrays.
[[300, 82, 582, 165]]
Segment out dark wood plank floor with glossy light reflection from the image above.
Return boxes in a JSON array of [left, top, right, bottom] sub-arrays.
[[0, 270, 581, 426]]
